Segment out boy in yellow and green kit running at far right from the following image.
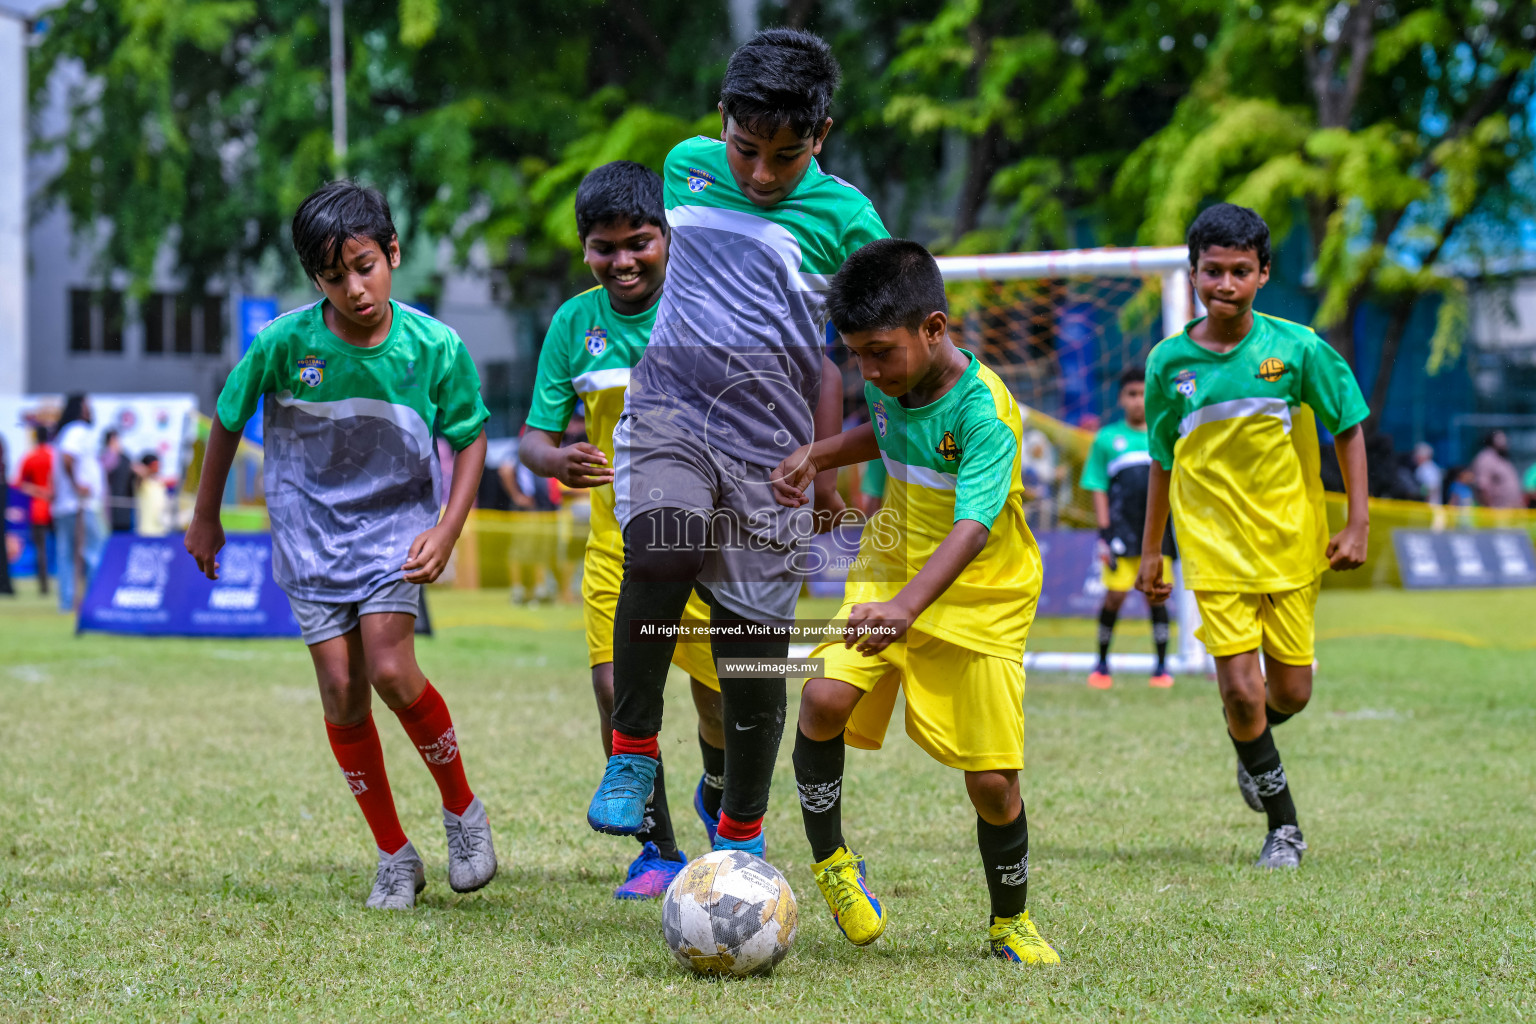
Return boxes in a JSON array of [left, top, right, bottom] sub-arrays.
[[1137, 203, 1370, 867]]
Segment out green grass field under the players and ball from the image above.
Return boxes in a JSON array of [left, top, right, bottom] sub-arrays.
[[0, 583, 1536, 1024]]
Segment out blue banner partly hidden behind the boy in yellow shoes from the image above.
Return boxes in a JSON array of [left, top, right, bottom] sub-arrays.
[[808, 527, 1155, 619]]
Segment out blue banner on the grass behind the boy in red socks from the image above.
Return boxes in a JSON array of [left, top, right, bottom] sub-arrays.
[[77, 533, 300, 637]]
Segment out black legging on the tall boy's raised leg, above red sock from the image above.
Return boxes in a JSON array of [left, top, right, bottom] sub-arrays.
[[613, 508, 703, 737]]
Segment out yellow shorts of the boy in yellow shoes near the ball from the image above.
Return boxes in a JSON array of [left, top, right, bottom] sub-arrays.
[[811, 605, 1025, 772]]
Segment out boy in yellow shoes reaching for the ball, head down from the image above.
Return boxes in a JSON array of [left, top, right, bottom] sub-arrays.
[[774, 239, 1060, 963]]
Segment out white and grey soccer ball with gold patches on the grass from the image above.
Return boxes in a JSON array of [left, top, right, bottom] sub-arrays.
[[662, 851, 800, 976]]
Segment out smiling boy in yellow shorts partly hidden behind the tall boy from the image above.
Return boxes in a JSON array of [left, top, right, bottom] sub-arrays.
[[518, 160, 725, 900]]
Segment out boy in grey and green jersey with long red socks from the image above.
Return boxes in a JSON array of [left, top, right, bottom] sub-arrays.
[[186, 181, 496, 910]]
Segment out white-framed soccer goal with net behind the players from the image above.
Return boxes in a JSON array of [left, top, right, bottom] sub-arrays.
[[938, 246, 1210, 674]]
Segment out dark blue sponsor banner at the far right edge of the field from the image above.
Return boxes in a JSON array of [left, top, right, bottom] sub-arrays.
[[1392, 530, 1536, 590]]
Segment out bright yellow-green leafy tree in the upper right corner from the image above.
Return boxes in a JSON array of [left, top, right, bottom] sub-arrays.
[[1115, 0, 1536, 416]]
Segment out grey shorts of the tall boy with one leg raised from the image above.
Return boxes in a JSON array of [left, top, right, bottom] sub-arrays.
[[613, 411, 816, 622]]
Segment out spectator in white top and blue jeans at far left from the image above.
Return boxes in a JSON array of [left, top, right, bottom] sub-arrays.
[[52, 393, 106, 611]]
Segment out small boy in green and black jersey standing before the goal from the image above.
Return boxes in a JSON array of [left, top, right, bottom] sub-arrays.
[[1078, 365, 1174, 689]]
